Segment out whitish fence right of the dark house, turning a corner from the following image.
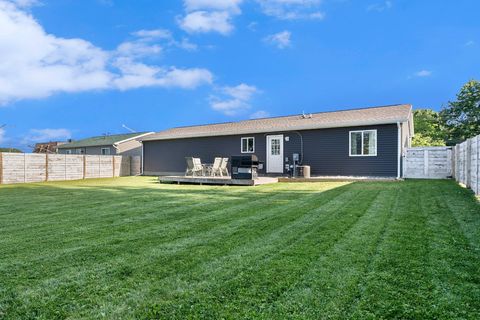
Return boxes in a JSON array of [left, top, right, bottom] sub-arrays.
[[403, 135, 480, 194]]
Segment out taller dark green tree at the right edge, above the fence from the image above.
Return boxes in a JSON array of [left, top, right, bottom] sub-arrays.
[[440, 80, 480, 145]]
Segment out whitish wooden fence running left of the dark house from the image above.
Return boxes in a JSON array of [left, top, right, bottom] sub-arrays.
[[0, 153, 141, 184]]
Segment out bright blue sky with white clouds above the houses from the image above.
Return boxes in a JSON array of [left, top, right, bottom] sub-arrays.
[[0, 0, 480, 150]]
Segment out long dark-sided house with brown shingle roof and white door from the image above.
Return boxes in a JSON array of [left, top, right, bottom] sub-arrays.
[[140, 105, 413, 177]]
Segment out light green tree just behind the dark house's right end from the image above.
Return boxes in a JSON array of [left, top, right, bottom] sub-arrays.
[[412, 109, 445, 147]]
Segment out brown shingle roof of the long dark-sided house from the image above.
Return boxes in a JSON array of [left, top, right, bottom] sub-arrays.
[[139, 104, 412, 141]]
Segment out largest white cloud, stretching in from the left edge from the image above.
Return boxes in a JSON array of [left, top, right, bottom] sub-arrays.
[[0, 0, 212, 104]]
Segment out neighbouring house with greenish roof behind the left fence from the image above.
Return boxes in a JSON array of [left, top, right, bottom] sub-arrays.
[[58, 132, 153, 156]]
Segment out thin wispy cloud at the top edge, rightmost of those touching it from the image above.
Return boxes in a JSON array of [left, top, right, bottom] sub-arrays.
[[257, 0, 325, 20]]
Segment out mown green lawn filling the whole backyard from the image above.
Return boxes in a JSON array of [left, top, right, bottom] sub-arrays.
[[0, 177, 480, 319]]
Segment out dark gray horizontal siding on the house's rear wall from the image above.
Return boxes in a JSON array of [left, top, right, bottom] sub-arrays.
[[144, 124, 398, 177]]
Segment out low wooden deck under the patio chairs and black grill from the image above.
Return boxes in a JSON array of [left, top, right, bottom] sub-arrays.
[[158, 176, 278, 186]]
